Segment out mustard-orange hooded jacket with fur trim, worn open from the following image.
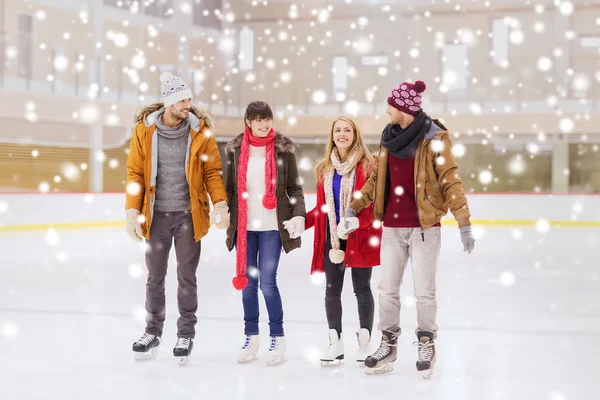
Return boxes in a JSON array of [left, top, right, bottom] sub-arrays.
[[125, 103, 227, 241]]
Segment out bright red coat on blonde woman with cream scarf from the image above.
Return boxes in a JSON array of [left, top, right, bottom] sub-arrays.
[[306, 162, 382, 274]]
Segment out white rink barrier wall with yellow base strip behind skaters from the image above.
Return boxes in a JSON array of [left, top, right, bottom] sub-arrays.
[[0, 193, 600, 232]]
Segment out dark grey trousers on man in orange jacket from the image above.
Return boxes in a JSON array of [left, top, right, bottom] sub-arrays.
[[146, 211, 200, 338]]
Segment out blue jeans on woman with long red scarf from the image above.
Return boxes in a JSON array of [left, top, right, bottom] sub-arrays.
[[242, 231, 283, 336]]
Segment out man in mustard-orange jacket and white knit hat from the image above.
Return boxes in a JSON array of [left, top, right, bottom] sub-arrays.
[[125, 72, 229, 363]]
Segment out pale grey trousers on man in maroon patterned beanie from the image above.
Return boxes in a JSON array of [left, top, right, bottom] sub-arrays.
[[379, 227, 441, 337]]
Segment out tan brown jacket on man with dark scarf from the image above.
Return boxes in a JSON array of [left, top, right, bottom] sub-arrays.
[[350, 120, 471, 229]]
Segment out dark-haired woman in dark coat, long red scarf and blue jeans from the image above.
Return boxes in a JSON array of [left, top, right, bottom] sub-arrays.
[[226, 102, 306, 365]]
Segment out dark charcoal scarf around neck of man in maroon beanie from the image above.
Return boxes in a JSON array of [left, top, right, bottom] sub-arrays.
[[381, 110, 431, 158]]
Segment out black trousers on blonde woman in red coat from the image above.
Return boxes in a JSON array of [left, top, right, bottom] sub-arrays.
[[324, 228, 375, 335]]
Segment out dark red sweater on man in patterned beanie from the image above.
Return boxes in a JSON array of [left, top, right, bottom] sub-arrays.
[[383, 154, 421, 228]]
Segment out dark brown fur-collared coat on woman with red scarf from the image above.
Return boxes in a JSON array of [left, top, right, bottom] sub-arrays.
[[225, 133, 306, 253]]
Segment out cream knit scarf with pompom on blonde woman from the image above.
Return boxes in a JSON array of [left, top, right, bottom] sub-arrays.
[[323, 148, 363, 264]]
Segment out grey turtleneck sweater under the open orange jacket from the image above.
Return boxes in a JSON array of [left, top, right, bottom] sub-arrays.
[[154, 110, 190, 212]]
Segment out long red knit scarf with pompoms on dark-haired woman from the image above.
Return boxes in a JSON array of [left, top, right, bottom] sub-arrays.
[[233, 126, 277, 290]]
